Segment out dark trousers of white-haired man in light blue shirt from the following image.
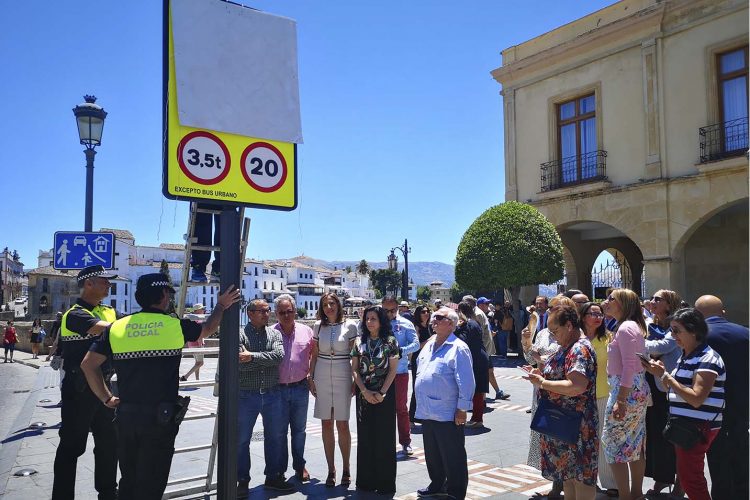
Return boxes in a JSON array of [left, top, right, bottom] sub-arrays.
[[422, 420, 469, 498]]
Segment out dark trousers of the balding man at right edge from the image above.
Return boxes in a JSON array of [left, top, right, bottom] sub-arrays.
[[707, 420, 750, 500]]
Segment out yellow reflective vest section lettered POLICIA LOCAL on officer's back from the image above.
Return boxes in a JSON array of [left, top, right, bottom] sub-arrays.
[[109, 312, 185, 360]]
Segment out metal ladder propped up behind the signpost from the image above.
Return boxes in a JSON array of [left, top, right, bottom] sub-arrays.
[[162, 202, 250, 499]]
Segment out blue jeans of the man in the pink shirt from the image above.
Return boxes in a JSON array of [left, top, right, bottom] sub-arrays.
[[279, 382, 310, 471]]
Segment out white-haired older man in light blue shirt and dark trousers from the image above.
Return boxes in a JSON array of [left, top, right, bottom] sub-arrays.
[[414, 307, 475, 498]]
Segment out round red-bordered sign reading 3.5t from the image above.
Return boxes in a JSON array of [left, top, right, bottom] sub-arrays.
[[177, 130, 231, 185]]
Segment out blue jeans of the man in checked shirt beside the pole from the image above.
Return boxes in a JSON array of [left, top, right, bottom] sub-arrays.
[[237, 387, 286, 481]]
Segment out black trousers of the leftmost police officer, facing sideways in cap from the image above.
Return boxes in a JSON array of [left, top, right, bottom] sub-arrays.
[[52, 369, 117, 500]]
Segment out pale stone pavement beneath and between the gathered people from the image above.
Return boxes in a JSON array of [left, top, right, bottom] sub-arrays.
[[0, 352, 676, 500]]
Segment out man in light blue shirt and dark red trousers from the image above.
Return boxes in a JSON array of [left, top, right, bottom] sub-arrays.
[[383, 295, 419, 455]]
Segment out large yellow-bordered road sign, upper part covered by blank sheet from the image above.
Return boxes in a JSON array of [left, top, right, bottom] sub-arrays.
[[162, 0, 297, 210]]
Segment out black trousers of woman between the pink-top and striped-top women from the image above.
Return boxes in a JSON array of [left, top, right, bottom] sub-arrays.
[[646, 373, 677, 484]]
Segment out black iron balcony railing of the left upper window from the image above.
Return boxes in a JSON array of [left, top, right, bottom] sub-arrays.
[[541, 150, 607, 191]]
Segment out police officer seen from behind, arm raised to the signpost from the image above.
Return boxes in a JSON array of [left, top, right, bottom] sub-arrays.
[[81, 273, 240, 500]]
